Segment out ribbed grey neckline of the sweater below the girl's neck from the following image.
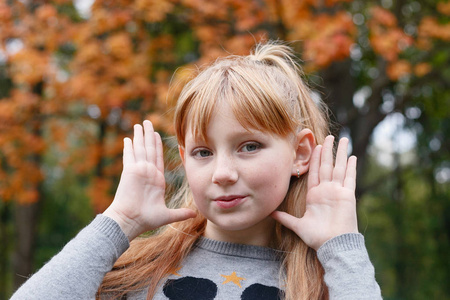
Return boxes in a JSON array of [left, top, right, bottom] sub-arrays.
[[196, 237, 280, 261]]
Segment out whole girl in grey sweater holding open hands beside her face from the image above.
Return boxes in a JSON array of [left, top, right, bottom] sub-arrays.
[[13, 43, 381, 300]]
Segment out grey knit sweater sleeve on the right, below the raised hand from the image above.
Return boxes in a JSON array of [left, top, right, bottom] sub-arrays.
[[317, 233, 382, 300]]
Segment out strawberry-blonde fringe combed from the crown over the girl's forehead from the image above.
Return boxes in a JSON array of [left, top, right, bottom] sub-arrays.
[[175, 61, 300, 146]]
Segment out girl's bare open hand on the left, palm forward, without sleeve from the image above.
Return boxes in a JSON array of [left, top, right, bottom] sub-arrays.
[[103, 120, 196, 241]]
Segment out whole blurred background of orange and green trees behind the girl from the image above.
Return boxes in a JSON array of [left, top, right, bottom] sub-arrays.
[[0, 0, 450, 299]]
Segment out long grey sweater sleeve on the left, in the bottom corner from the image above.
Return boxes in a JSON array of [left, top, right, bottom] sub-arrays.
[[11, 215, 129, 300]]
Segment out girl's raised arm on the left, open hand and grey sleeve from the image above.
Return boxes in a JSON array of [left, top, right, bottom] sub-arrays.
[[12, 121, 195, 299]]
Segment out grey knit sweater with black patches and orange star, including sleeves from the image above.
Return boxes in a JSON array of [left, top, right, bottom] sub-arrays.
[[11, 215, 381, 300]]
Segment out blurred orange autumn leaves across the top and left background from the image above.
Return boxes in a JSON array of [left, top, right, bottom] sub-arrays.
[[0, 0, 450, 211]]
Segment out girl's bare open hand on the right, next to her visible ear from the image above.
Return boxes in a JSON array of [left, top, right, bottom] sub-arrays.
[[272, 136, 358, 250]]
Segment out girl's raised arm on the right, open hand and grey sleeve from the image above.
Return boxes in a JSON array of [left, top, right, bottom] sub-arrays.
[[272, 136, 381, 299]]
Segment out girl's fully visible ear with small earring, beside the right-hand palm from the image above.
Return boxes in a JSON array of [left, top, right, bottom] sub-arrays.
[[292, 129, 316, 177]]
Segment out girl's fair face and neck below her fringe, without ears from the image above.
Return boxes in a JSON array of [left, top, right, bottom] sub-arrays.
[[180, 104, 297, 245]]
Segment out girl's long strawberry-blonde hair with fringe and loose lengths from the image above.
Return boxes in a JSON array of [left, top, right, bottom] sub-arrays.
[[99, 42, 329, 300]]
